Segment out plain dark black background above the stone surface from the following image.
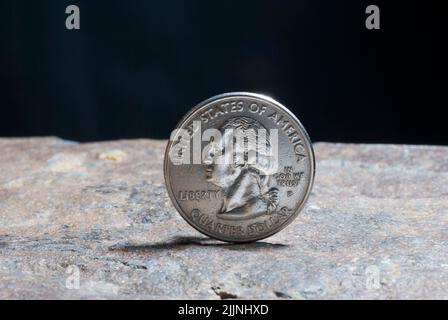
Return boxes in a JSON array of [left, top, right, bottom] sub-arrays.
[[0, 0, 448, 144]]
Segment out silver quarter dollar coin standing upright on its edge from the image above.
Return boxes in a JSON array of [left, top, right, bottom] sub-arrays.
[[164, 92, 315, 242]]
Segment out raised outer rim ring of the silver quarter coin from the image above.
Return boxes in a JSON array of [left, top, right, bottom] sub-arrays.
[[163, 92, 316, 243]]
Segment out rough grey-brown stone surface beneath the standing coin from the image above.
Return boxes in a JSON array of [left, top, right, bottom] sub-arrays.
[[0, 138, 448, 299]]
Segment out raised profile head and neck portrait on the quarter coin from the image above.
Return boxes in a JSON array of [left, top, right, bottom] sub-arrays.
[[203, 117, 279, 219]]
